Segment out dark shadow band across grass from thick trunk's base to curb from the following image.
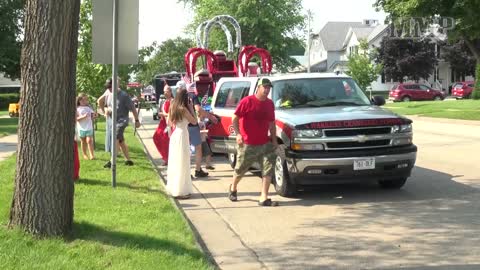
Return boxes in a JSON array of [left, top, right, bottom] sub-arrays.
[[71, 222, 204, 260]]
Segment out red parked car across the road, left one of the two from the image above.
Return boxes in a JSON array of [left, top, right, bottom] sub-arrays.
[[388, 83, 445, 102]]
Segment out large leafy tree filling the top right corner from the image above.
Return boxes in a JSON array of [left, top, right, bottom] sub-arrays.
[[375, 0, 480, 98]]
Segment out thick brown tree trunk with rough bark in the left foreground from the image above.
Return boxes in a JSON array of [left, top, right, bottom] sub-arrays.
[[9, 0, 80, 236]]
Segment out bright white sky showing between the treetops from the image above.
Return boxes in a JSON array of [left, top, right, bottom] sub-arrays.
[[138, 0, 385, 47]]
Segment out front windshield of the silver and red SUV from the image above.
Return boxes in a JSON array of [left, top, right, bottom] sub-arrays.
[[272, 78, 371, 109]]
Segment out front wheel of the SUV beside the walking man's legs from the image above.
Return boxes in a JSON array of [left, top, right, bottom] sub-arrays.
[[273, 145, 297, 197]]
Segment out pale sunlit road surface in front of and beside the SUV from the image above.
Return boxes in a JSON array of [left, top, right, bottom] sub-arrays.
[[139, 110, 480, 270]]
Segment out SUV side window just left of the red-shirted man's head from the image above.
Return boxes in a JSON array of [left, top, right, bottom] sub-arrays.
[[215, 82, 250, 109]]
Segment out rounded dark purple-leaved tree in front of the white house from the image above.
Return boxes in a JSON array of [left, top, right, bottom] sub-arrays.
[[376, 36, 437, 82]]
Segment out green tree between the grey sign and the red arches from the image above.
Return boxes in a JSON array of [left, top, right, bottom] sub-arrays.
[[136, 38, 194, 85]]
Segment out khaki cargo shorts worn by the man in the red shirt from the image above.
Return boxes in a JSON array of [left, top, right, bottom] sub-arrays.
[[233, 143, 276, 177]]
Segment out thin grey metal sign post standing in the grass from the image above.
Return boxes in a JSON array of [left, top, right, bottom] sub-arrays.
[[111, 0, 119, 188]]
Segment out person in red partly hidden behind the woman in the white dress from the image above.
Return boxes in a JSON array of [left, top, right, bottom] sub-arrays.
[[153, 85, 172, 165]]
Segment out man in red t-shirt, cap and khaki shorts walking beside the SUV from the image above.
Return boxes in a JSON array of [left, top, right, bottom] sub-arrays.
[[228, 78, 278, 206]]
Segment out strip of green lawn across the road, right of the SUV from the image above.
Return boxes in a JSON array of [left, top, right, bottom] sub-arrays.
[[384, 100, 480, 120]]
